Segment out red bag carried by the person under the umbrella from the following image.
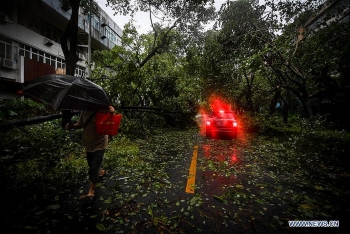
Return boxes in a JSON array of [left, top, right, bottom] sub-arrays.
[[96, 112, 122, 136]]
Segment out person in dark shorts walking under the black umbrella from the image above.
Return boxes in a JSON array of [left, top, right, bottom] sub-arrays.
[[65, 106, 114, 204]]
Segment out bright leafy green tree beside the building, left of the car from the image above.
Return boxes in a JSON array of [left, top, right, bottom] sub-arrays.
[[94, 24, 200, 111]]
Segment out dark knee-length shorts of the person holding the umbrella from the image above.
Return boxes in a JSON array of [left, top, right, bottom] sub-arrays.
[[86, 150, 105, 183]]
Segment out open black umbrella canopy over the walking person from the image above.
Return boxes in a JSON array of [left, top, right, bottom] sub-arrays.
[[22, 74, 111, 110]]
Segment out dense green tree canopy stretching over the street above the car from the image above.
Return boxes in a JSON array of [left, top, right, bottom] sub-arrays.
[[2, 0, 350, 130]]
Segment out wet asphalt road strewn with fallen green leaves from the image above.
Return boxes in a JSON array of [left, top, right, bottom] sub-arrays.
[[12, 122, 348, 234]]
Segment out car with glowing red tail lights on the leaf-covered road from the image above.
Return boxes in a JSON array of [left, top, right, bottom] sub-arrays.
[[205, 110, 238, 138]]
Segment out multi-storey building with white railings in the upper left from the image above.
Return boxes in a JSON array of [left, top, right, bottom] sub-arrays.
[[0, 0, 122, 99]]
